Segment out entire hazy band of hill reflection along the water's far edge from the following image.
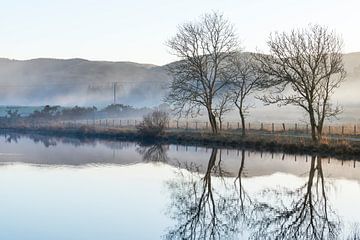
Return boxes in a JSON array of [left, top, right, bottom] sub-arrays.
[[0, 133, 360, 180]]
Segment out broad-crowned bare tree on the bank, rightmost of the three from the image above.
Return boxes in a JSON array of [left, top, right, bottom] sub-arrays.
[[254, 25, 346, 143]]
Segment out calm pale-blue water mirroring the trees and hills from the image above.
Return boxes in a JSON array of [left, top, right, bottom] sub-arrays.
[[0, 134, 360, 240]]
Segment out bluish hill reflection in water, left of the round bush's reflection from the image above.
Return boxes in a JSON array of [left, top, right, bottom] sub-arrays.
[[0, 134, 141, 166]]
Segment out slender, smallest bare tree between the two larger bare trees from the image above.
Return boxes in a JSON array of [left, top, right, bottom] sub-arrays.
[[228, 54, 263, 136]]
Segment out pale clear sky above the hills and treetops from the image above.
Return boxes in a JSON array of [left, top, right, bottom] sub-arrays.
[[0, 0, 360, 65]]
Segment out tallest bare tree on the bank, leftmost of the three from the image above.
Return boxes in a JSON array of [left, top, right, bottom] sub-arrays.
[[166, 12, 239, 133]]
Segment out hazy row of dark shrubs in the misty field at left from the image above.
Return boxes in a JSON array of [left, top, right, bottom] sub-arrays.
[[0, 104, 167, 121]]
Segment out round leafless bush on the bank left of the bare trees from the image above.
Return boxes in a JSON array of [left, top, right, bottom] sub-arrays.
[[137, 110, 169, 137]]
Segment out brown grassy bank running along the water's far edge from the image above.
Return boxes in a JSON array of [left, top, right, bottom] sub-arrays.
[[2, 119, 360, 160]]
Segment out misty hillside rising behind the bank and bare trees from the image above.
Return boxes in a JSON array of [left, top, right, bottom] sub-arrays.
[[0, 53, 360, 111]]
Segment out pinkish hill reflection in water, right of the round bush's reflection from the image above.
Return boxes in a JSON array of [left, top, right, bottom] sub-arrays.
[[168, 146, 360, 180]]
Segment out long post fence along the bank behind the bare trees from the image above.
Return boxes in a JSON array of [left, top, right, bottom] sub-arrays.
[[27, 119, 360, 136]]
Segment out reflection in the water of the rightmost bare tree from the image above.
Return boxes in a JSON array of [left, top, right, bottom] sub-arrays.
[[250, 156, 340, 239]]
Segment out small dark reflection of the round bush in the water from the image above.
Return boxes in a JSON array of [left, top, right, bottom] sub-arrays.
[[137, 144, 168, 163]]
